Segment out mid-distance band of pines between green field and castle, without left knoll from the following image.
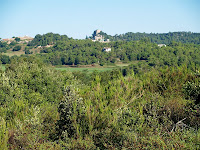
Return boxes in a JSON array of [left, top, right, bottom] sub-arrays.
[[36, 40, 200, 66]]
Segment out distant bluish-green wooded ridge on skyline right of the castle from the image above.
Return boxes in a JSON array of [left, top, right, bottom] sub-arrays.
[[100, 32, 200, 44]]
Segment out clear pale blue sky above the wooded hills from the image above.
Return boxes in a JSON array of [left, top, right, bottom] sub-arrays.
[[0, 0, 200, 39]]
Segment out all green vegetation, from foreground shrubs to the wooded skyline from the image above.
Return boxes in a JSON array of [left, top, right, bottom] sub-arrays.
[[0, 32, 200, 150]]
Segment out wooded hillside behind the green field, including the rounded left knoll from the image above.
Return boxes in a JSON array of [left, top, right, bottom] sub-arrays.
[[0, 33, 200, 66]]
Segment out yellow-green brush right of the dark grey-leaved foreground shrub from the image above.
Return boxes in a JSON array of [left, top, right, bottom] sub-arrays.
[[55, 67, 200, 149]]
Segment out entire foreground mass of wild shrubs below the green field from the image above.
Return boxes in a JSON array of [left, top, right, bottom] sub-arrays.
[[0, 52, 200, 149]]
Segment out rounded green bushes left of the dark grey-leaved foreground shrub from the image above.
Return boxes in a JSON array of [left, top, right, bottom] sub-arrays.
[[0, 58, 72, 149]]
